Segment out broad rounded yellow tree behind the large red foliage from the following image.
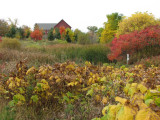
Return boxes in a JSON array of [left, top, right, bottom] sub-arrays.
[[116, 12, 160, 37]]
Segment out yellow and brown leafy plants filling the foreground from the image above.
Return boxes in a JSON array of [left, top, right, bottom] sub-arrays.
[[0, 62, 160, 120]]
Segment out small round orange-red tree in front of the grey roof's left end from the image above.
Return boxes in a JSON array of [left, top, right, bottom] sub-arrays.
[[30, 30, 43, 41]]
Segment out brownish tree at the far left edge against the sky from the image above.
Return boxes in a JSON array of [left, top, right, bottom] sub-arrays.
[[0, 19, 9, 36]]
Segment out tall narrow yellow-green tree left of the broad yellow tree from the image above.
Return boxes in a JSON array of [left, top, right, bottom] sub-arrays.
[[100, 13, 123, 43]]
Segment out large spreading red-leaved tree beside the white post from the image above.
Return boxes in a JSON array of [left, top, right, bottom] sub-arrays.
[[108, 25, 160, 60]]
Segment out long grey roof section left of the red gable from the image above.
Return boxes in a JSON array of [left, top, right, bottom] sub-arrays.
[[36, 23, 57, 30]]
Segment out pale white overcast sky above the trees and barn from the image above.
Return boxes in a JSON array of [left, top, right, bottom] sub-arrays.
[[0, 0, 160, 32]]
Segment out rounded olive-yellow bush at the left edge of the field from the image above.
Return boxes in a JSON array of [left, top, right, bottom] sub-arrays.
[[0, 38, 21, 49]]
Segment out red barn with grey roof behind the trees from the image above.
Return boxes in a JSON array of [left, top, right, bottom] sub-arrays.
[[35, 19, 71, 38]]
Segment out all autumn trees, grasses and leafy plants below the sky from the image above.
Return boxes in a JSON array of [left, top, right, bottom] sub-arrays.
[[0, 12, 160, 120]]
